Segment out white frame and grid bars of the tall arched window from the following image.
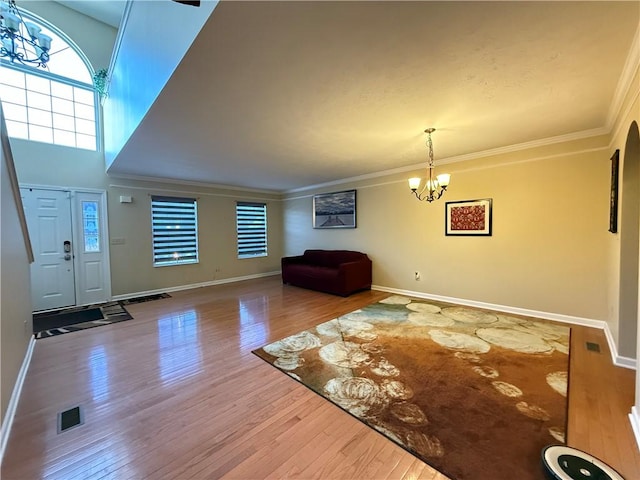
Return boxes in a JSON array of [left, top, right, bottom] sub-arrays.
[[0, 7, 103, 152]]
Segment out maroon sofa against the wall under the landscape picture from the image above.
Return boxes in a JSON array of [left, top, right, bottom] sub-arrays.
[[281, 250, 371, 297]]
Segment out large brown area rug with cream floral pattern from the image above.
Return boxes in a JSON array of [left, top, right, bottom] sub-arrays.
[[253, 296, 570, 480]]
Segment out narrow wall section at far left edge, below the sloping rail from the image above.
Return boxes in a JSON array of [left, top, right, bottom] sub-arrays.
[[0, 137, 33, 421]]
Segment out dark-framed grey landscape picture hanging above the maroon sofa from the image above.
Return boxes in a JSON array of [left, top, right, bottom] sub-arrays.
[[313, 190, 356, 228]]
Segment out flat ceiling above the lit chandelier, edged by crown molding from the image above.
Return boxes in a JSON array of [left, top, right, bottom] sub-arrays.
[[101, 1, 640, 191]]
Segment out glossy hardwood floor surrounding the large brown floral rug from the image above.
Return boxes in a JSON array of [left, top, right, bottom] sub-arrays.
[[1, 277, 640, 480]]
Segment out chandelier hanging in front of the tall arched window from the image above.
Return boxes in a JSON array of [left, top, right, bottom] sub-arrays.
[[0, 0, 51, 68]]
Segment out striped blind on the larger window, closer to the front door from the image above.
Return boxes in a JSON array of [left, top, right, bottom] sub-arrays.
[[151, 196, 198, 266]]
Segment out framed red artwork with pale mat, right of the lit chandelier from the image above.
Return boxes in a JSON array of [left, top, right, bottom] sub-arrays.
[[445, 198, 493, 237]]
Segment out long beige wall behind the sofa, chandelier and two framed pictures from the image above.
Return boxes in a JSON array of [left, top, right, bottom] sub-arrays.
[[284, 137, 609, 320]]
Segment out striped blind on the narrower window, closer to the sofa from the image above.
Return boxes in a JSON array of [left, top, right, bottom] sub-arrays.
[[236, 202, 267, 258]]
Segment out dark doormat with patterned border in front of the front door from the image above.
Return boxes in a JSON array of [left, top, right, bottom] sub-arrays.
[[33, 302, 133, 339]]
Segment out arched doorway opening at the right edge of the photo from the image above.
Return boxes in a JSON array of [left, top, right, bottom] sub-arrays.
[[618, 121, 640, 358]]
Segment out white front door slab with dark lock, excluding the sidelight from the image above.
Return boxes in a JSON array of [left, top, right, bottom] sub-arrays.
[[20, 188, 76, 311]]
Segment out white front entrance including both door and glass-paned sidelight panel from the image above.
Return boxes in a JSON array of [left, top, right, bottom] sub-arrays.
[[20, 187, 111, 311]]
